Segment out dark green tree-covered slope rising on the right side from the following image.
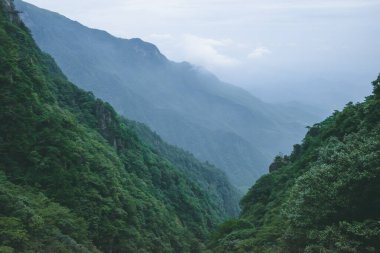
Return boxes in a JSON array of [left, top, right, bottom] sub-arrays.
[[209, 76, 380, 253]]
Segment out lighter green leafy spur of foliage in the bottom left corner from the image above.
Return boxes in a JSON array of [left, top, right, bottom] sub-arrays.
[[0, 172, 98, 252]]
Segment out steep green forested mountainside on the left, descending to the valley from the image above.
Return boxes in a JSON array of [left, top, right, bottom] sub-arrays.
[[0, 0, 238, 253]]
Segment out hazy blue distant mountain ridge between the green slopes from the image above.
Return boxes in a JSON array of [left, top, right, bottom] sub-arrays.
[[16, 1, 319, 190]]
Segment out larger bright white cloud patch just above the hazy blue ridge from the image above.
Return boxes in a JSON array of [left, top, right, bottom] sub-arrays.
[[183, 34, 239, 68]]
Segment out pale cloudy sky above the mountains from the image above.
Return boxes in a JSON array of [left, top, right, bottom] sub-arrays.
[[23, 0, 380, 110]]
